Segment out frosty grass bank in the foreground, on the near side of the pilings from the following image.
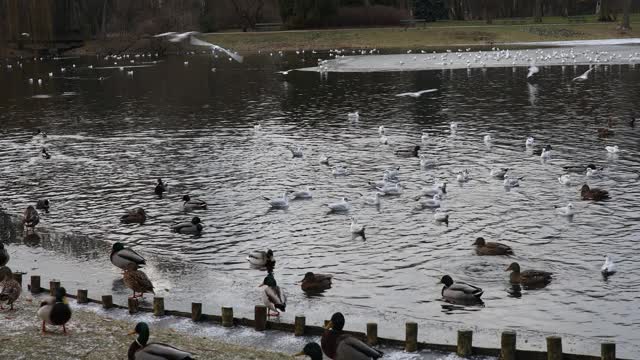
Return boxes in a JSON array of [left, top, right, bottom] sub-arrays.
[[0, 292, 291, 360]]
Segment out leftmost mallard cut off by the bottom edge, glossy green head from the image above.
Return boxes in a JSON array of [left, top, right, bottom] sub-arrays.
[[127, 322, 193, 360]]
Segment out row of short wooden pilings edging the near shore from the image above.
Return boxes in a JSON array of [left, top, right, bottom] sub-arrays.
[[14, 274, 616, 360]]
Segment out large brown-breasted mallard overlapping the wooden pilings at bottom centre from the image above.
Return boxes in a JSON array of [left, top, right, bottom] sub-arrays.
[[320, 312, 384, 360]]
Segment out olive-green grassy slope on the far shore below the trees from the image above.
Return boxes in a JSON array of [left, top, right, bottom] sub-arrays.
[[204, 16, 640, 53]]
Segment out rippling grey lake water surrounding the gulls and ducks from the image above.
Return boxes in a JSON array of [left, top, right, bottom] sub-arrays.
[[0, 53, 640, 358]]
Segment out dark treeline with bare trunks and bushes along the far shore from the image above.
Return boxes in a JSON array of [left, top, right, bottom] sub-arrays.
[[0, 0, 640, 41]]
